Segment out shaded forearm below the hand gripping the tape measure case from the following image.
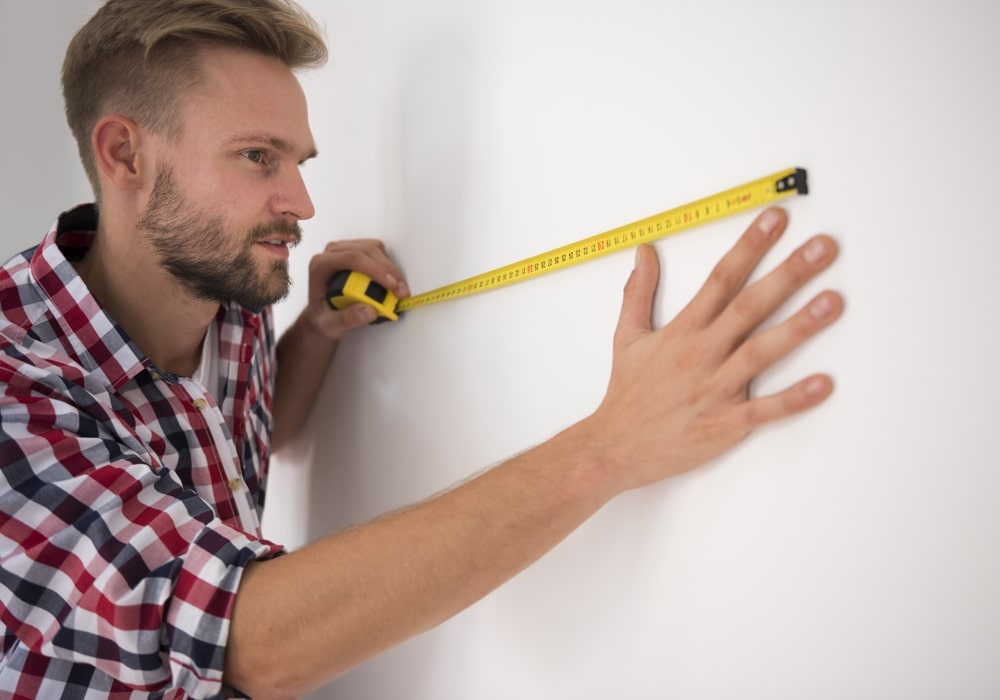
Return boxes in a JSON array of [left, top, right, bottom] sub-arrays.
[[271, 314, 338, 452]]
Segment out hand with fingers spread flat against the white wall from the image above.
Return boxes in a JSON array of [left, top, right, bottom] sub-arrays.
[[589, 208, 844, 492]]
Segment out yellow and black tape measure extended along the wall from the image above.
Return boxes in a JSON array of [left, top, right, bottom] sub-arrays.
[[327, 168, 809, 323]]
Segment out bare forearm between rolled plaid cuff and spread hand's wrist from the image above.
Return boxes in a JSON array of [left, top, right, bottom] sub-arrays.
[[226, 418, 614, 697]]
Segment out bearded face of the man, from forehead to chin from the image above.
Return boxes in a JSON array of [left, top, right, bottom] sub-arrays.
[[138, 43, 315, 308]]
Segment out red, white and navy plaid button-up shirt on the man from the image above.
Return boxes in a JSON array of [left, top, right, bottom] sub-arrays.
[[0, 206, 280, 699]]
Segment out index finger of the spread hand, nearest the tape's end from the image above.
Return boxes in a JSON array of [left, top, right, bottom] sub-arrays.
[[678, 207, 788, 327]]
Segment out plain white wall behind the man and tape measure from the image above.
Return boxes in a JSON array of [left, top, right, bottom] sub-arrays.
[[0, 0, 1000, 700]]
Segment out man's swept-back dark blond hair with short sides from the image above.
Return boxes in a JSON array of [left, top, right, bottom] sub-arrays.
[[62, 0, 327, 197]]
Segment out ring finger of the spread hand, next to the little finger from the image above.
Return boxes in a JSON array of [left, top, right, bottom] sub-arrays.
[[719, 291, 844, 391]]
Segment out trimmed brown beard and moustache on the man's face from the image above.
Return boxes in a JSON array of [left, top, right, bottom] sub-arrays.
[[137, 166, 302, 309]]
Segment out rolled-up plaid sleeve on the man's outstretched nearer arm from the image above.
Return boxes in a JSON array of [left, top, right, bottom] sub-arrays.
[[0, 380, 280, 698]]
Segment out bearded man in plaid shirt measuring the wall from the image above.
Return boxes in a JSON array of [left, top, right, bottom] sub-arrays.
[[0, 0, 843, 698]]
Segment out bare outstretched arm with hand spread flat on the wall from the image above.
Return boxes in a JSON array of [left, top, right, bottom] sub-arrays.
[[234, 215, 843, 697]]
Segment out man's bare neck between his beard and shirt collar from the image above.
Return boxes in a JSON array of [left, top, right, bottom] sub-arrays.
[[74, 209, 219, 377]]
